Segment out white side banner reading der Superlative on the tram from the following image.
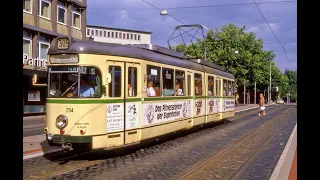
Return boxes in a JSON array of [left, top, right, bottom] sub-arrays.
[[142, 100, 191, 126]]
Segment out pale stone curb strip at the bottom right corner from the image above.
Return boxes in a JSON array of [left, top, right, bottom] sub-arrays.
[[269, 124, 297, 180]]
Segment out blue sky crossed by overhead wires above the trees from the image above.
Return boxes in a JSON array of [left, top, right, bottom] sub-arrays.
[[87, 0, 297, 72]]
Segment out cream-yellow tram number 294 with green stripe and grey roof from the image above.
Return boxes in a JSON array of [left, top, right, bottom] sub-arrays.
[[33, 37, 235, 150]]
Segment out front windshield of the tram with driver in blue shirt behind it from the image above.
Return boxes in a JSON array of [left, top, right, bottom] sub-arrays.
[[48, 66, 101, 98]]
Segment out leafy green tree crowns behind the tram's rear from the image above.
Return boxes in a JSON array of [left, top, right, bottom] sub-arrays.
[[174, 24, 290, 97]]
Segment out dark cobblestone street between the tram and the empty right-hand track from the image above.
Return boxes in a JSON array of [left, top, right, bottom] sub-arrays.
[[24, 106, 292, 179]]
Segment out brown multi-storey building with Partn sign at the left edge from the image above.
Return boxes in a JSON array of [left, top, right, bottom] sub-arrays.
[[23, 0, 87, 115]]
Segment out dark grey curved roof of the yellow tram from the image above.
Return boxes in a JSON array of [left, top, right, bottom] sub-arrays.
[[48, 37, 234, 78]]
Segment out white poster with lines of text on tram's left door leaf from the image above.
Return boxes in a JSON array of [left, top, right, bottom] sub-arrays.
[[107, 103, 124, 132]]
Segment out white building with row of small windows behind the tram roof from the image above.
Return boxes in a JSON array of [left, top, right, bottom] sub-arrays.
[[86, 25, 152, 44]]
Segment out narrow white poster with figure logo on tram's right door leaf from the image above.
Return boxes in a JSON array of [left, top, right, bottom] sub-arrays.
[[126, 102, 140, 130]]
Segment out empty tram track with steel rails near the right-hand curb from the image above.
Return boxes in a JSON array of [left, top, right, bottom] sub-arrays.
[[176, 108, 292, 180]]
